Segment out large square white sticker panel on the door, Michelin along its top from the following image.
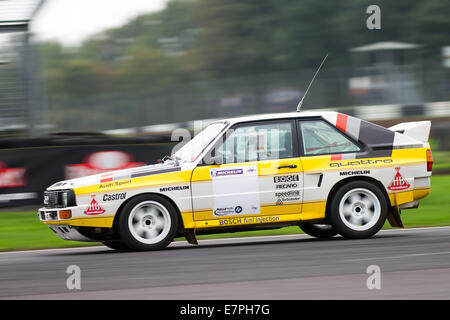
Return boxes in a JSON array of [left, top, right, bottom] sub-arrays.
[[209, 165, 261, 217]]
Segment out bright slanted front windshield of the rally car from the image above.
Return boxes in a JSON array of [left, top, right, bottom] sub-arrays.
[[173, 122, 227, 162]]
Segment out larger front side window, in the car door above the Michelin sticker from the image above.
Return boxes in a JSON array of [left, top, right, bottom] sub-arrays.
[[216, 122, 294, 163]]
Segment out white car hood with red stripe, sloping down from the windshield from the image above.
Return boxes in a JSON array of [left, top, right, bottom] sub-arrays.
[[47, 163, 181, 190]]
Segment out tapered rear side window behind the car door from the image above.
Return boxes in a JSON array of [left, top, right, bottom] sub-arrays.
[[300, 120, 360, 155]]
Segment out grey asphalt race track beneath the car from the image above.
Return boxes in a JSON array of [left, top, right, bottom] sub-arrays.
[[0, 227, 450, 300]]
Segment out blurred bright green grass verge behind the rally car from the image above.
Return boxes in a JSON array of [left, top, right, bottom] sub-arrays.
[[0, 176, 450, 251]]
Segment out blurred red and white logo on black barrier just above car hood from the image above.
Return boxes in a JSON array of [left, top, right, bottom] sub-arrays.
[[64, 151, 146, 182]]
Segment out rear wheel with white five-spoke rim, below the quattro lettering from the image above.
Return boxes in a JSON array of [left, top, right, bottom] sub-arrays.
[[329, 181, 388, 239]]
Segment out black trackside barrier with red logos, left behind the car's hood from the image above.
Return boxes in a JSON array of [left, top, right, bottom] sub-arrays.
[[0, 136, 175, 207]]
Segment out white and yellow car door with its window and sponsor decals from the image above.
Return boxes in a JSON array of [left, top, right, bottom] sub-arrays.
[[192, 119, 303, 222]]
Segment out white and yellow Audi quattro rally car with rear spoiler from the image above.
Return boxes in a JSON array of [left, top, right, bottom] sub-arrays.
[[39, 111, 433, 250]]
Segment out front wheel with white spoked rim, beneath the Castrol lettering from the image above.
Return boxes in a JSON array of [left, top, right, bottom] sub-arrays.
[[118, 195, 178, 251]]
